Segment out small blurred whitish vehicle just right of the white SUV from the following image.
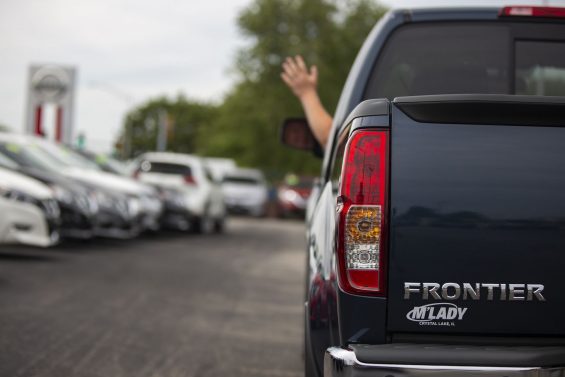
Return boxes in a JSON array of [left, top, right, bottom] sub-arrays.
[[222, 169, 269, 216]]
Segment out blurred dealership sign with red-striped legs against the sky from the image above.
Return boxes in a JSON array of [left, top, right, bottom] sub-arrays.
[[26, 65, 76, 143]]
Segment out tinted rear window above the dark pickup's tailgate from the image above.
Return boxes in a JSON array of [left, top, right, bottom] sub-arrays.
[[365, 21, 565, 99]]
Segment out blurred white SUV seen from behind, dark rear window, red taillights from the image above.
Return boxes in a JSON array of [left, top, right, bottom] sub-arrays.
[[134, 152, 226, 233]]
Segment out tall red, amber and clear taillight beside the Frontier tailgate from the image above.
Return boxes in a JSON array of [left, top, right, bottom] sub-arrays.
[[337, 131, 389, 296]]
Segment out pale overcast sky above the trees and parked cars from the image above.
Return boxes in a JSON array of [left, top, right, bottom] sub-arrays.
[[0, 0, 565, 151]]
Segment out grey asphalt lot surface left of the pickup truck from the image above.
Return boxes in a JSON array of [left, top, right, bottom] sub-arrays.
[[0, 218, 304, 377]]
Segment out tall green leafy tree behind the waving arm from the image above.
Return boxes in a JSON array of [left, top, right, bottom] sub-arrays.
[[197, 0, 385, 173]]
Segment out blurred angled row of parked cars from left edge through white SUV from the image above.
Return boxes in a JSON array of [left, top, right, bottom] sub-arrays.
[[0, 133, 227, 247]]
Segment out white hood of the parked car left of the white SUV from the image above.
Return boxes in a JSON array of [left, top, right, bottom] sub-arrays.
[[62, 168, 152, 195]]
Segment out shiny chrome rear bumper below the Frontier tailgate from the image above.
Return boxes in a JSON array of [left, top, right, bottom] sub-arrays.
[[324, 347, 565, 377]]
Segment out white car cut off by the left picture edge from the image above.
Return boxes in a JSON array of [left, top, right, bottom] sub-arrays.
[[0, 168, 60, 247]]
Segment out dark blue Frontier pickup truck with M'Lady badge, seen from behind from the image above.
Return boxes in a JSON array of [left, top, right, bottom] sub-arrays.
[[283, 7, 565, 377]]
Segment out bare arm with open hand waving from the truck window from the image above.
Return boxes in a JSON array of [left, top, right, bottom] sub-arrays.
[[281, 56, 332, 147]]
